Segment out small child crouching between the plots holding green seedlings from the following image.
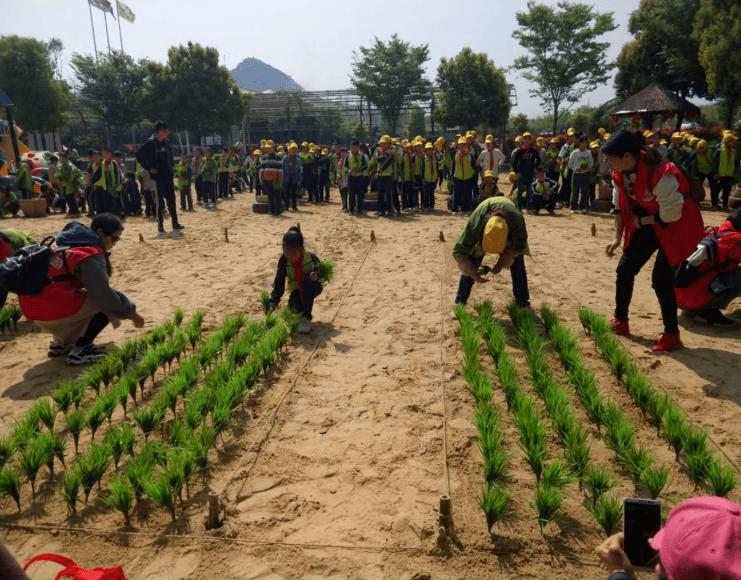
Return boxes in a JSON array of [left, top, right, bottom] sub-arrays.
[[270, 225, 322, 334]]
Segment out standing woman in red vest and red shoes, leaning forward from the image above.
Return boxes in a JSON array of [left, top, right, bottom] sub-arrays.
[[602, 130, 704, 352]]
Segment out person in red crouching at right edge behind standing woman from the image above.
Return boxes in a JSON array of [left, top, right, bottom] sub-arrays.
[[676, 208, 741, 326]]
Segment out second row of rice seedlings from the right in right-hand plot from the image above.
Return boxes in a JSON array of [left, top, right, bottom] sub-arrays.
[[540, 306, 669, 500]]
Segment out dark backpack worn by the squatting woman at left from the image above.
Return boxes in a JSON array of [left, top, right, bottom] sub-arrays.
[[0, 236, 72, 307]]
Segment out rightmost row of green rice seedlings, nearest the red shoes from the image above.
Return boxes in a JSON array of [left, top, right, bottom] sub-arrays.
[[579, 308, 738, 497]]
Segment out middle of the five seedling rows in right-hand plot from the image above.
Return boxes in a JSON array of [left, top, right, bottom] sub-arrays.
[[509, 303, 622, 536]]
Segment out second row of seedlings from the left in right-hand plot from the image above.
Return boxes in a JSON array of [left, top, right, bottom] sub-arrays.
[[477, 305, 569, 533]]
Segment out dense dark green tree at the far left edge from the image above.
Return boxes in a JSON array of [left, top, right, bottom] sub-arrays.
[[0, 36, 70, 131]]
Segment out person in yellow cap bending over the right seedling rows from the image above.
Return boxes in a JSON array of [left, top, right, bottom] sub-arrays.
[[453, 195, 530, 307]]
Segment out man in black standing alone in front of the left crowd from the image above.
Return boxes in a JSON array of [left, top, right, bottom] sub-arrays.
[[136, 121, 183, 233]]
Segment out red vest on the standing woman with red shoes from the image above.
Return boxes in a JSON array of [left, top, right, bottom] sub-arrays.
[[612, 155, 705, 268]]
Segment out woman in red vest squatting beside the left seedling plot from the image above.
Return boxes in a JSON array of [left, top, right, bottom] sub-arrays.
[[18, 213, 144, 365]]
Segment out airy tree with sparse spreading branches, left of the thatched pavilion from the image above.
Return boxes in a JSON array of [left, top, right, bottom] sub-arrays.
[[512, 0, 617, 133]]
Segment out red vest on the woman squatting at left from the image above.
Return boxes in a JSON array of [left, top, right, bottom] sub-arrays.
[[18, 246, 107, 321]]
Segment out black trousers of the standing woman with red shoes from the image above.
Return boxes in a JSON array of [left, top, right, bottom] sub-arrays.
[[615, 226, 679, 333]]
